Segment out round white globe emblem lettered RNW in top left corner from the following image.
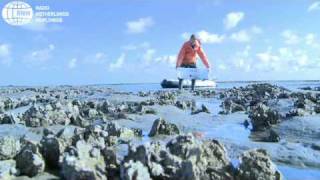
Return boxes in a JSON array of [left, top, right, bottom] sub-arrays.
[[2, 1, 33, 26]]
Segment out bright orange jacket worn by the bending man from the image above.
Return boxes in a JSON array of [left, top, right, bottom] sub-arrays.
[[176, 40, 210, 68]]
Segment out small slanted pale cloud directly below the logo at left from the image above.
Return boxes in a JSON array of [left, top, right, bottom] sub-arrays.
[[24, 44, 55, 65]]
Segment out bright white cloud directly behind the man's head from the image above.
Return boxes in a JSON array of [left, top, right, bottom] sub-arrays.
[[181, 30, 225, 44]]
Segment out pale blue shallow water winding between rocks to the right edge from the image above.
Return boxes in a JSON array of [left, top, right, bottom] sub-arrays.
[[112, 95, 320, 180]]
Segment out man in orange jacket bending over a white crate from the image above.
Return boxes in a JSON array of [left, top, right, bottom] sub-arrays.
[[176, 34, 210, 90]]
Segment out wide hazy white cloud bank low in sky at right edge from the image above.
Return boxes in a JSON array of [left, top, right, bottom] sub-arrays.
[[225, 36, 320, 75]]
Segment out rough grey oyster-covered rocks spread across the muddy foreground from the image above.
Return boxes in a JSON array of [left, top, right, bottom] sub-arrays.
[[0, 84, 320, 180]]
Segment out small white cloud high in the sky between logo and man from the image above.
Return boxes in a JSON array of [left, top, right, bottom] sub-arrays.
[[126, 17, 154, 34]]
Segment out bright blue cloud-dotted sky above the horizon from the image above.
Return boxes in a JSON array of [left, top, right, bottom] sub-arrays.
[[0, 0, 320, 85]]
